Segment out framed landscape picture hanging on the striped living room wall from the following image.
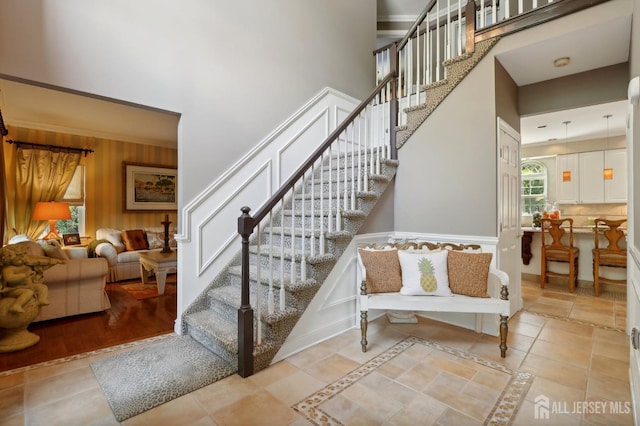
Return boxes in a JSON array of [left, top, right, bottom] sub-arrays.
[[122, 162, 178, 211]]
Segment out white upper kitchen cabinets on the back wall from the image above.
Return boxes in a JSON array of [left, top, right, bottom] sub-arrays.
[[557, 149, 627, 204]]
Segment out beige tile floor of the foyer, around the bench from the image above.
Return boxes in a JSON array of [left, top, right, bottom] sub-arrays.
[[0, 285, 633, 425]]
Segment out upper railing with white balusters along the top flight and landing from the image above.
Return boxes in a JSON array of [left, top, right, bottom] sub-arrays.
[[374, 0, 607, 125]]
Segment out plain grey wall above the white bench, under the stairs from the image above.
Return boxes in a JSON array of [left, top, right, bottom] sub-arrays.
[[395, 55, 497, 236]]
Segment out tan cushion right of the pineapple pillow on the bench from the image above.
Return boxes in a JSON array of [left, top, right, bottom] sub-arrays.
[[447, 251, 493, 297]]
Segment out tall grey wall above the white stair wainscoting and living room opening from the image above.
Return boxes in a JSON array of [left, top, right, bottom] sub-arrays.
[[0, 0, 376, 205]]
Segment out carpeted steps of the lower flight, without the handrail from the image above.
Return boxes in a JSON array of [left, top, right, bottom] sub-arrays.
[[184, 152, 398, 372]]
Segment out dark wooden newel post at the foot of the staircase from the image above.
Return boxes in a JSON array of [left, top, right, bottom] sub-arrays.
[[238, 206, 253, 377]]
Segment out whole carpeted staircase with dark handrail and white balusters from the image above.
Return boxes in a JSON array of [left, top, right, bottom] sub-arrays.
[[183, 0, 589, 377]]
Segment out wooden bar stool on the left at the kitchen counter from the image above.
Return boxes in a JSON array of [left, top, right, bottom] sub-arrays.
[[540, 218, 580, 293]]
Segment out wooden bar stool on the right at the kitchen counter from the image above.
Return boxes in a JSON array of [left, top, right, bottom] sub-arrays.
[[593, 218, 627, 296]]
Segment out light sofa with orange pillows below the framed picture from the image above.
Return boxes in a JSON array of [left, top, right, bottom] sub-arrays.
[[95, 227, 177, 282]]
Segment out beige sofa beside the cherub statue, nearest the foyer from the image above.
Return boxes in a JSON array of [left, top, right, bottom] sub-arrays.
[[9, 240, 111, 322]]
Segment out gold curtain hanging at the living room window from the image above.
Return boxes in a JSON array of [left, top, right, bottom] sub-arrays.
[[5, 147, 80, 239]]
